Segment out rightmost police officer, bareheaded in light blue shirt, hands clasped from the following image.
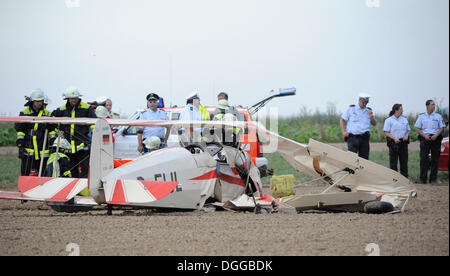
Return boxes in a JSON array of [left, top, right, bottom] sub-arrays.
[[414, 100, 445, 184]]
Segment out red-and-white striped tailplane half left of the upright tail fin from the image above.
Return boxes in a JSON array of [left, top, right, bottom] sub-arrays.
[[18, 176, 88, 202]]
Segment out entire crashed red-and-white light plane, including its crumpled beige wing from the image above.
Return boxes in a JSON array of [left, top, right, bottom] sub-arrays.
[[0, 89, 416, 214]]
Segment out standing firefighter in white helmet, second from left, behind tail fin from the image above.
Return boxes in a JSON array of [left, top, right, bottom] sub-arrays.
[[52, 87, 97, 178]]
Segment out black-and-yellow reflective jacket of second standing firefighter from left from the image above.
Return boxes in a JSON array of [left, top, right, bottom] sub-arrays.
[[51, 101, 97, 153]]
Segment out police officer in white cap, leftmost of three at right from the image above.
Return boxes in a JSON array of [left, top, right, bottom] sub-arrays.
[[340, 93, 377, 159]]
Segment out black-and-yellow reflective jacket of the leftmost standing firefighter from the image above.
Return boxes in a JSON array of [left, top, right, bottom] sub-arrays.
[[14, 102, 55, 160]]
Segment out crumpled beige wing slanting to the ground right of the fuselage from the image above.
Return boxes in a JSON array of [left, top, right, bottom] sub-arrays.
[[258, 123, 416, 208]]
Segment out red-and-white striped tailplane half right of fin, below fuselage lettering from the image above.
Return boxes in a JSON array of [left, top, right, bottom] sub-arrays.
[[105, 180, 178, 205]]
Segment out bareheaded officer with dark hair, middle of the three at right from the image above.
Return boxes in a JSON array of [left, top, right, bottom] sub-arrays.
[[383, 104, 411, 177]]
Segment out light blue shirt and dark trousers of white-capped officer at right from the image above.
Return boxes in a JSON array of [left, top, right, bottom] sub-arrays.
[[341, 104, 372, 159]]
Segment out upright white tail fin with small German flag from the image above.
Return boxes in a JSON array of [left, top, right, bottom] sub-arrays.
[[89, 119, 114, 204]]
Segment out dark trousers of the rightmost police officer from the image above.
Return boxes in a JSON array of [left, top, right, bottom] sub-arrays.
[[420, 136, 442, 183]]
